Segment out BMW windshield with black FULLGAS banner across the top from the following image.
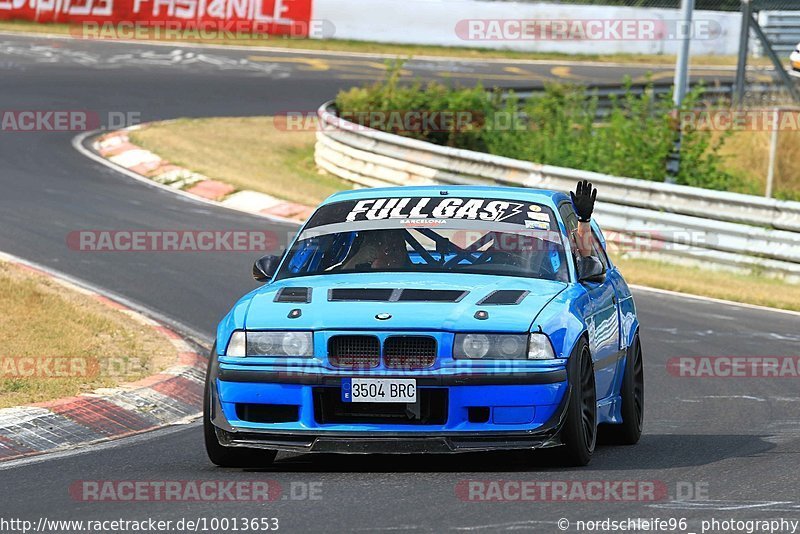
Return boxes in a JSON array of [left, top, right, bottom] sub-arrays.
[[277, 197, 569, 281]]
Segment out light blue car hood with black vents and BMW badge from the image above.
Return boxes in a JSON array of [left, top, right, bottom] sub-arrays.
[[245, 273, 567, 332]]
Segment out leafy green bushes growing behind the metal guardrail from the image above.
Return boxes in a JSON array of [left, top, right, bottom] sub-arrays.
[[336, 62, 742, 194]]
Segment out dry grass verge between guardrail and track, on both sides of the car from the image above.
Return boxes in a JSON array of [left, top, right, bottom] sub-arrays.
[[122, 117, 800, 311]]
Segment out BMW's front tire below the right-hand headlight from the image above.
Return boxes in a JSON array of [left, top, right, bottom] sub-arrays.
[[561, 337, 597, 467]]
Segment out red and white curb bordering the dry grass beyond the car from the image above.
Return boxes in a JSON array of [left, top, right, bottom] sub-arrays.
[[92, 125, 314, 222]]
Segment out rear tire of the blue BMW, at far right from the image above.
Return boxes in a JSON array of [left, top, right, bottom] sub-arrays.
[[601, 332, 644, 445]]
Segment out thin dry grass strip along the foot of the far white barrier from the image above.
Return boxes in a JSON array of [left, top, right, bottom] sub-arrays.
[[0, 20, 756, 66]]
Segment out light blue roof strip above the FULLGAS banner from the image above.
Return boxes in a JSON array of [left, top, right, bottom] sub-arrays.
[[322, 185, 569, 207]]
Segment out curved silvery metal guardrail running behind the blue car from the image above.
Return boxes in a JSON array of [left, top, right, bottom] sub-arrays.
[[315, 103, 800, 281]]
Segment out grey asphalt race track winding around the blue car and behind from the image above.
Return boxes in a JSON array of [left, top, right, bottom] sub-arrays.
[[0, 35, 800, 532]]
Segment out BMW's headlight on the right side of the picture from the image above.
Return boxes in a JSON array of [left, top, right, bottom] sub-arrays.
[[453, 333, 555, 360]]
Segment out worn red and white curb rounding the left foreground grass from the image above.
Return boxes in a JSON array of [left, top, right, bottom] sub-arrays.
[[0, 253, 206, 462]]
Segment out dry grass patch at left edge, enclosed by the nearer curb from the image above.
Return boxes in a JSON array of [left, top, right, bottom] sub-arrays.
[[0, 262, 177, 408]]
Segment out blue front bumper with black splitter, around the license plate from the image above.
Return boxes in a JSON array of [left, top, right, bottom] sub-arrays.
[[209, 365, 569, 454]]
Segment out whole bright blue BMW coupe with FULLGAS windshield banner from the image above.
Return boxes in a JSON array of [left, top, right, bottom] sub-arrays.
[[204, 186, 644, 467]]
